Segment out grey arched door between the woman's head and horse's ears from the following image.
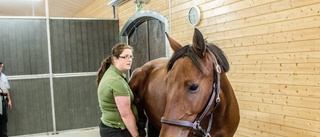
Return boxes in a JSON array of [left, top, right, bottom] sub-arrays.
[[129, 19, 166, 73]]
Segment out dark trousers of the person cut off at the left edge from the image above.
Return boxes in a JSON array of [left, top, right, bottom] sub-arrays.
[[0, 99, 8, 137]]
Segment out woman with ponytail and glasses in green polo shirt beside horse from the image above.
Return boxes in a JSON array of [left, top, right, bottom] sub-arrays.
[[96, 43, 139, 137]]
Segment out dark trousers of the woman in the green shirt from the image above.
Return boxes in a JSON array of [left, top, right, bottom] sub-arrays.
[[99, 122, 131, 137]]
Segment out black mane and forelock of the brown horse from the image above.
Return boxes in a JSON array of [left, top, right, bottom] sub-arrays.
[[167, 41, 229, 72]]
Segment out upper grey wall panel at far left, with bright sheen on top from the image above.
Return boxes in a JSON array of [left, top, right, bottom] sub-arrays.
[[0, 19, 49, 75]]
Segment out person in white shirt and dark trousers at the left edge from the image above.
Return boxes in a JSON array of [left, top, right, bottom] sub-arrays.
[[0, 60, 12, 137]]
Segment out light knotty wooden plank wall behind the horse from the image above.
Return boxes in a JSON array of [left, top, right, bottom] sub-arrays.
[[77, 0, 320, 137]]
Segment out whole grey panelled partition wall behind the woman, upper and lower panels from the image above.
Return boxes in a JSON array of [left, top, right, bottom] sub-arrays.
[[0, 19, 119, 135]]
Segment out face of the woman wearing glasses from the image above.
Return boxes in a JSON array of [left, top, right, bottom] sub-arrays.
[[114, 49, 133, 72]]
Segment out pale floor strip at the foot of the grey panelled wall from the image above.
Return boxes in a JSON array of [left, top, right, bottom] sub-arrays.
[[10, 127, 100, 137]]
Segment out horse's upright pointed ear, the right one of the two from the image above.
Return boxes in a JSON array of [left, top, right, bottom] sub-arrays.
[[192, 28, 206, 58]]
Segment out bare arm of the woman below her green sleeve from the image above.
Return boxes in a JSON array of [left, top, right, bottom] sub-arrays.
[[114, 96, 139, 137]]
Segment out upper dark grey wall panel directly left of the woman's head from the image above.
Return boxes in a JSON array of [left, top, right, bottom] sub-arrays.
[[50, 19, 119, 73]]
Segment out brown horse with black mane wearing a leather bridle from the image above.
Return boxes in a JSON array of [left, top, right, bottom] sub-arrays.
[[129, 29, 240, 137]]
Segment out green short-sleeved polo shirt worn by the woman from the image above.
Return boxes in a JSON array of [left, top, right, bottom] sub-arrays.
[[98, 65, 138, 129]]
